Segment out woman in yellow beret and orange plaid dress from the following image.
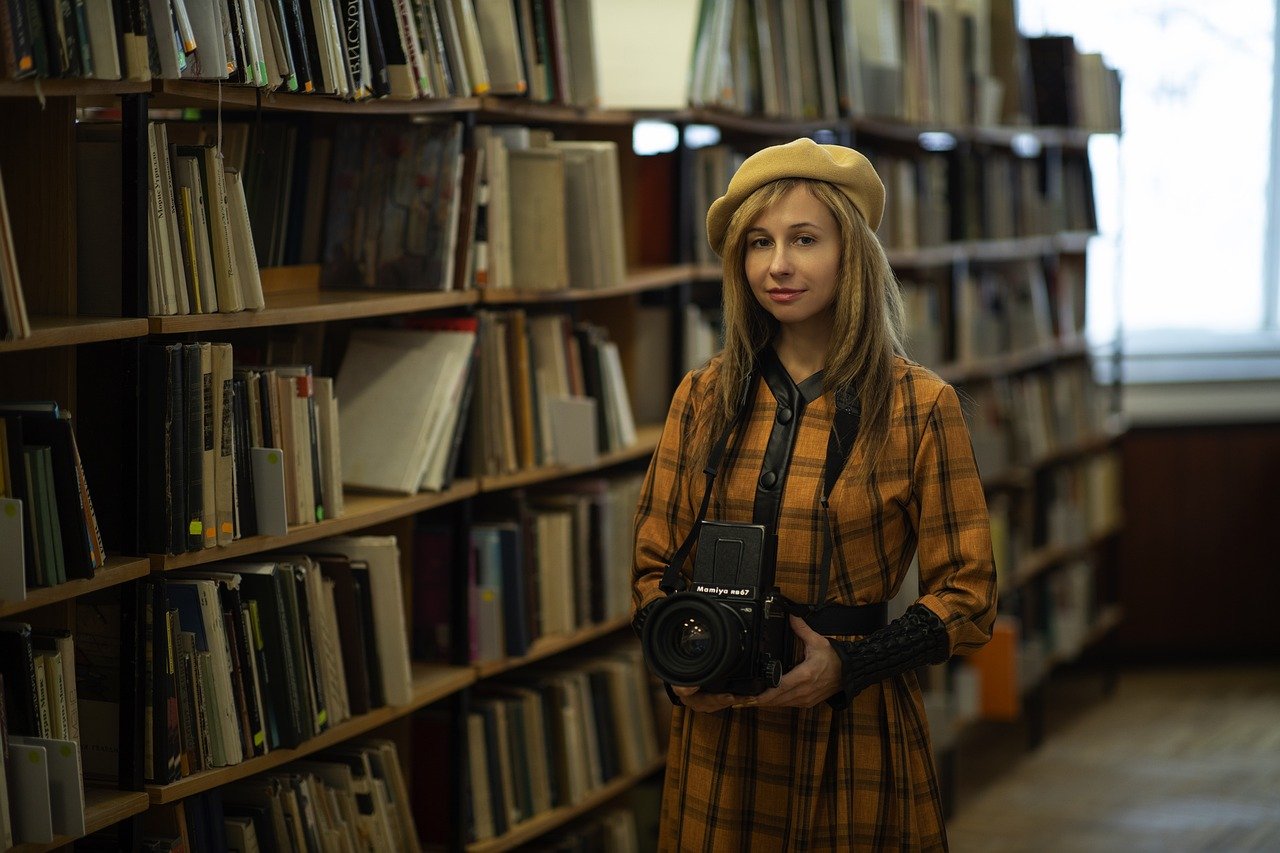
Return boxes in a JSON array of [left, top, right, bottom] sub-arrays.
[[634, 140, 996, 852]]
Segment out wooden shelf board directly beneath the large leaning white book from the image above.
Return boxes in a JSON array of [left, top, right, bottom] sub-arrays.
[[151, 480, 479, 571]]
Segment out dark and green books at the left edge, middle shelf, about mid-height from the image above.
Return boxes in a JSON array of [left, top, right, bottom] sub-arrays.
[[0, 401, 106, 601]]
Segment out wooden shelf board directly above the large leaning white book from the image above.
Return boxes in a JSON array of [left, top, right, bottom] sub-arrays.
[[147, 289, 479, 334]]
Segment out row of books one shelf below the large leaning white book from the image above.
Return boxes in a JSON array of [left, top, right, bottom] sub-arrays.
[[131, 537, 412, 784]]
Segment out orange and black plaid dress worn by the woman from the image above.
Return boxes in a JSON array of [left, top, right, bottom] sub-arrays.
[[634, 359, 996, 853]]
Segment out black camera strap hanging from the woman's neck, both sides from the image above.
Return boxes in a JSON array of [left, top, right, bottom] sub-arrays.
[[658, 365, 861, 596]]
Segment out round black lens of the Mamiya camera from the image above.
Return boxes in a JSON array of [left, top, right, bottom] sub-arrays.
[[641, 593, 746, 686]]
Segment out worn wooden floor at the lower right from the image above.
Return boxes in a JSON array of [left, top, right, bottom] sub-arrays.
[[948, 662, 1280, 853]]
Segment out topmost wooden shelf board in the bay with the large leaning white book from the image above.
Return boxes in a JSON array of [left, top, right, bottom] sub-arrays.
[[151, 79, 480, 115]]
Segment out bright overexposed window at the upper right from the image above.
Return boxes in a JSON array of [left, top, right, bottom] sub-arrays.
[[1019, 0, 1280, 380]]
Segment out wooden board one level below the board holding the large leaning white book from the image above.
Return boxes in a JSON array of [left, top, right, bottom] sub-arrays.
[[146, 663, 475, 804]]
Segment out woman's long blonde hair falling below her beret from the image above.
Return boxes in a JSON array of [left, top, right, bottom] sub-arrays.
[[694, 178, 905, 476]]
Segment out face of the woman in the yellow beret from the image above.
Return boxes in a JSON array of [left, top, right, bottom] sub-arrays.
[[744, 186, 840, 333]]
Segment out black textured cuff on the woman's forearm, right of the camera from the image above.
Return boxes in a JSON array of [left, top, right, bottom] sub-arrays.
[[827, 605, 950, 711]]
